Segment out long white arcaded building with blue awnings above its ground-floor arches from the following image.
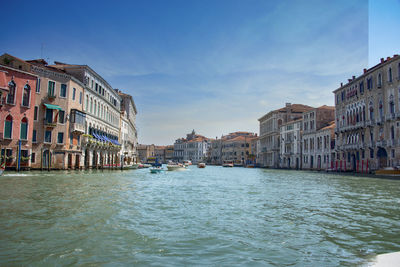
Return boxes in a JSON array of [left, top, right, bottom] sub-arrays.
[[51, 62, 121, 168]]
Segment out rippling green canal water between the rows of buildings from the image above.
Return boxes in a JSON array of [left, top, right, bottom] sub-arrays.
[[0, 166, 400, 266]]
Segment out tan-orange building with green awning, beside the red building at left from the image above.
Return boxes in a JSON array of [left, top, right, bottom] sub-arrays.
[[0, 54, 85, 169]]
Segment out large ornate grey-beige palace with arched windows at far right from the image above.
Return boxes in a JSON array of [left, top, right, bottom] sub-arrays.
[[333, 55, 400, 172]]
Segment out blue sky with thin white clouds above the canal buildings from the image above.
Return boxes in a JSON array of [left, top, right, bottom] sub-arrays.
[[0, 0, 400, 145]]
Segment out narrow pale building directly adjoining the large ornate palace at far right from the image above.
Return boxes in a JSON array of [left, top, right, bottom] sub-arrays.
[[301, 105, 335, 170]]
